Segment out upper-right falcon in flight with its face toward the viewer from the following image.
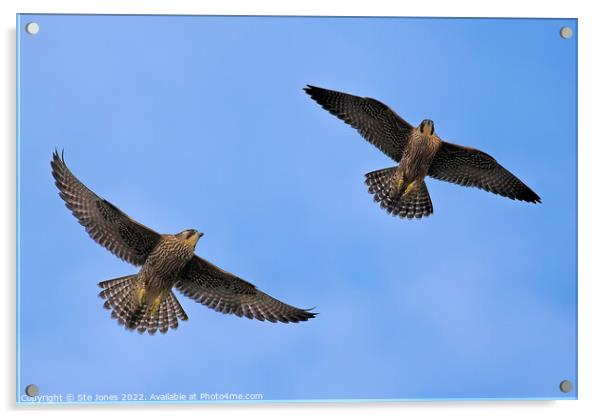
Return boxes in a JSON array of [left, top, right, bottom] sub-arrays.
[[304, 85, 541, 218]]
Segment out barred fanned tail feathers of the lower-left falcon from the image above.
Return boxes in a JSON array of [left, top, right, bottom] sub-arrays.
[[98, 275, 188, 335]]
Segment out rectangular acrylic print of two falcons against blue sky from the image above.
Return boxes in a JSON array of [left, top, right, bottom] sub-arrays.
[[17, 15, 577, 403]]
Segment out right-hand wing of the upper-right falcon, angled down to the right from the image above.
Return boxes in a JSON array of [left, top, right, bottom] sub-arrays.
[[428, 141, 541, 203]]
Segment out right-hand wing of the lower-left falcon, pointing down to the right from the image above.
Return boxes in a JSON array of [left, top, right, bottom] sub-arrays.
[[175, 256, 317, 323]]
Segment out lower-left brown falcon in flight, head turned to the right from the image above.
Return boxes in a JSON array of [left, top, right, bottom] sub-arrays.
[[51, 151, 316, 335]]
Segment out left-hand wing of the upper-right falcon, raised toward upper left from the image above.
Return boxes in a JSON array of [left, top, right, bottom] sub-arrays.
[[304, 85, 414, 162]]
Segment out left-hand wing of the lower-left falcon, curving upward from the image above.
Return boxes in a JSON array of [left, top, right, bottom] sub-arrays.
[[50, 151, 161, 265]]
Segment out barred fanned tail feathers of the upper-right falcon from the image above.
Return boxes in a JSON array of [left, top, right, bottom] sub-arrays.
[[366, 167, 433, 218]]
